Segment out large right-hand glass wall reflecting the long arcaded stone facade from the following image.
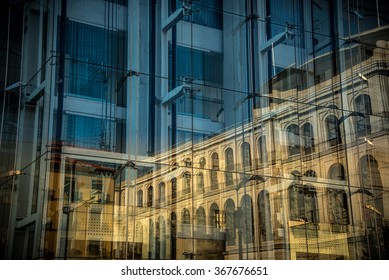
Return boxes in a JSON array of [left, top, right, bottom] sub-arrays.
[[123, 1, 387, 259]]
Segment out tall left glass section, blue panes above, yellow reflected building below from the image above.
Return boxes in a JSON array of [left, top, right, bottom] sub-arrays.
[[40, 0, 129, 259]]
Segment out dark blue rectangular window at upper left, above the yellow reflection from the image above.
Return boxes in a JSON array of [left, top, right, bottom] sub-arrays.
[[64, 20, 126, 102]]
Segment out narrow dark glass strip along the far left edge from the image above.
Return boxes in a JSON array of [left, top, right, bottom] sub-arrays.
[[0, 1, 24, 259]]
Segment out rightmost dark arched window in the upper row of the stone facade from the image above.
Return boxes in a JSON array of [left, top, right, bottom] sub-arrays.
[[355, 94, 373, 137]]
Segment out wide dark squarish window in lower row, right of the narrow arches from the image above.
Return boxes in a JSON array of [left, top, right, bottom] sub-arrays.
[[289, 184, 319, 223]]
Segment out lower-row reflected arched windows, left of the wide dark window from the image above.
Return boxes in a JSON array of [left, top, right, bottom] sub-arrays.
[[136, 190, 273, 253]]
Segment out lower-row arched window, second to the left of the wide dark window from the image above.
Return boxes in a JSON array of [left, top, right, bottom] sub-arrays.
[[239, 195, 254, 243]]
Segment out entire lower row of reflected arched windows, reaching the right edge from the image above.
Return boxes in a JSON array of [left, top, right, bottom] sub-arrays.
[[136, 155, 383, 258]]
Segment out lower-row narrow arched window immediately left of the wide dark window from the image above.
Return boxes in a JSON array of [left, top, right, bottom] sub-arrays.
[[258, 190, 273, 241]]
